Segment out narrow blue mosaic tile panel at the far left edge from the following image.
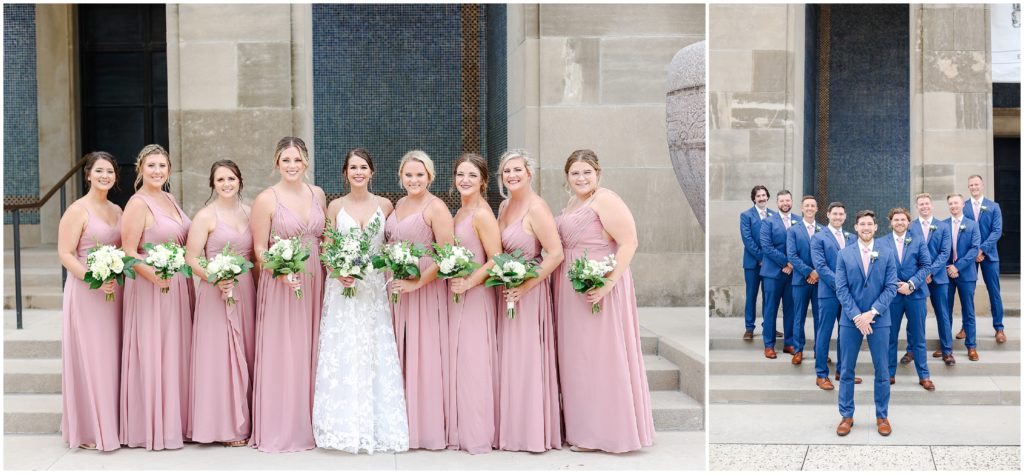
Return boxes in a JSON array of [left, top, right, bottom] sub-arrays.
[[3, 4, 39, 224]]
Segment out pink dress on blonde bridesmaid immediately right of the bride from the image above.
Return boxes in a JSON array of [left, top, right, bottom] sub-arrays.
[[384, 198, 449, 449]]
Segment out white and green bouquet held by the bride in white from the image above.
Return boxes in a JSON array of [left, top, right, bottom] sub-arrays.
[[321, 216, 381, 298]]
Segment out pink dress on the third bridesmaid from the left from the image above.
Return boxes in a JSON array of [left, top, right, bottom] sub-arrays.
[[188, 208, 256, 442]]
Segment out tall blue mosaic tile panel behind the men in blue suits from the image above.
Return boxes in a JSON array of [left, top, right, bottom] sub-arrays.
[[805, 4, 910, 234]]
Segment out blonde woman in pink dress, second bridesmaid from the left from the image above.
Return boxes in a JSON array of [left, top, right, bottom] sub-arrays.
[[121, 144, 193, 449]]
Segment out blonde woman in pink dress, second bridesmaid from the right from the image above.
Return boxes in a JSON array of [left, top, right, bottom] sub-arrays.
[[498, 149, 563, 453]]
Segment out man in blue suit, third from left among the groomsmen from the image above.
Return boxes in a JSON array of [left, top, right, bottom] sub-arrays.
[[785, 196, 821, 365]]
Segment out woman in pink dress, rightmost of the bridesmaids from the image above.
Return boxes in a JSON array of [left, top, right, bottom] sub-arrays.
[[554, 149, 654, 453]]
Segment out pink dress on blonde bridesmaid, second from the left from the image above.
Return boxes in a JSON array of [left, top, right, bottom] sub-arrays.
[[121, 193, 194, 450]]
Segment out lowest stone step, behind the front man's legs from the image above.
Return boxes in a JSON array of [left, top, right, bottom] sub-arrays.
[[711, 372, 1021, 406]]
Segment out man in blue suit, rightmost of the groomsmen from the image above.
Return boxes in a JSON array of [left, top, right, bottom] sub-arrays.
[[956, 174, 1007, 344]]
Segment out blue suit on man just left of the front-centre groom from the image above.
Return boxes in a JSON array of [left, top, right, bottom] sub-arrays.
[[811, 227, 857, 379]]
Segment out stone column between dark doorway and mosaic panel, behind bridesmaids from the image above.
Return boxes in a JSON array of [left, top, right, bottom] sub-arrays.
[[167, 4, 313, 214]]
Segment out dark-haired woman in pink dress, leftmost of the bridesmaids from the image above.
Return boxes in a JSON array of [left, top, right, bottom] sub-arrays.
[[57, 152, 122, 450]]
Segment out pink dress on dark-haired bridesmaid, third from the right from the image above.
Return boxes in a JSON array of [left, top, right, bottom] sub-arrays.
[[447, 206, 498, 455]]
